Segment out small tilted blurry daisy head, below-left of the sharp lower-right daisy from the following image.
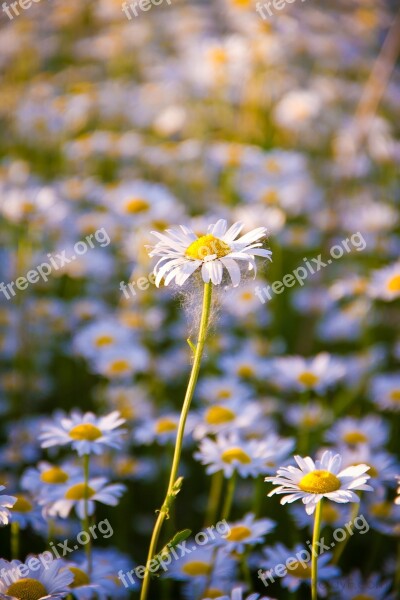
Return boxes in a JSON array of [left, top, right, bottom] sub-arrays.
[[212, 513, 275, 554]]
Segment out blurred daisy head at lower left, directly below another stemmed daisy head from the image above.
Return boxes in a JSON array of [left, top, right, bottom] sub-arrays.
[[41, 477, 126, 519]]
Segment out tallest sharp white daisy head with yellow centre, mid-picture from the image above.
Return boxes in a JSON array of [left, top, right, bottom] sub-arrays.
[[149, 219, 272, 287]]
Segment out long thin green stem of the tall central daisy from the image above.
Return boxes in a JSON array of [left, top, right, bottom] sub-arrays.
[[140, 283, 212, 600]]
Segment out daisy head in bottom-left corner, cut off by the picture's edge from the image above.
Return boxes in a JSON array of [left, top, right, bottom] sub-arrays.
[[0, 556, 74, 600]]
